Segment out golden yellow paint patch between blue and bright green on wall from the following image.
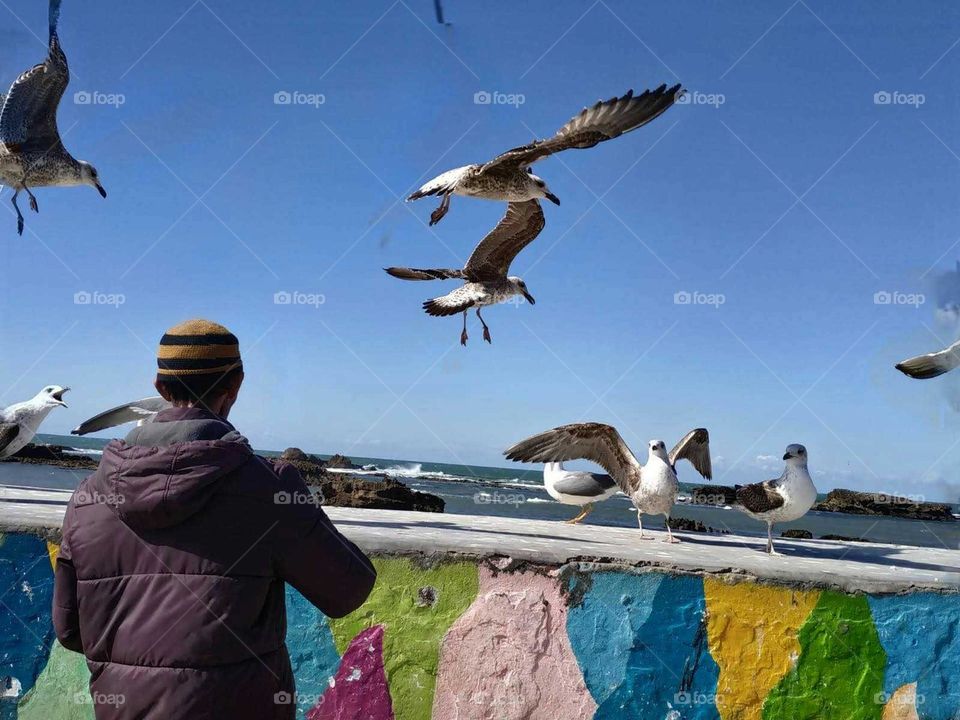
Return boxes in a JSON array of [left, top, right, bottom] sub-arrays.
[[703, 578, 820, 720]]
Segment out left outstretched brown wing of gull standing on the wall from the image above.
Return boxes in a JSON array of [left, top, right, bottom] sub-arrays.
[[504, 423, 640, 495]]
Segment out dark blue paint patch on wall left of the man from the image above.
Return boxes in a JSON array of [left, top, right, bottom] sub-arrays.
[[0, 534, 55, 696]]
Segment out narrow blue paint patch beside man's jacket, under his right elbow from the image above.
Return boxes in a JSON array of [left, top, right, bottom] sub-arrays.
[[287, 585, 340, 718]]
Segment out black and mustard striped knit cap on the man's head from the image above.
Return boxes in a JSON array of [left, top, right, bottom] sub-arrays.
[[157, 320, 243, 380]]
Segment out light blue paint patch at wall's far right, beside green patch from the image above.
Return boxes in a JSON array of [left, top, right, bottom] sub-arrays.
[[867, 593, 960, 720]]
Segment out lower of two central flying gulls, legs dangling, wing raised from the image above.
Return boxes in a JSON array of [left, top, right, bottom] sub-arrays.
[[385, 200, 544, 345]]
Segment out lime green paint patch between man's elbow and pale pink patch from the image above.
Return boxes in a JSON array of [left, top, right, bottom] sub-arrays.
[[330, 558, 480, 720]]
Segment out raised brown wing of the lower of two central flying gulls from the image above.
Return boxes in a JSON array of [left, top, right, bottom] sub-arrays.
[[463, 200, 546, 282]]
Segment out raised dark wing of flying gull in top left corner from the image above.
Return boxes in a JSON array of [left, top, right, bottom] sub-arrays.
[[0, 0, 70, 152]]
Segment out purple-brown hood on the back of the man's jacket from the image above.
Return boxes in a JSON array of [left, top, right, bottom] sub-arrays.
[[85, 408, 253, 530]]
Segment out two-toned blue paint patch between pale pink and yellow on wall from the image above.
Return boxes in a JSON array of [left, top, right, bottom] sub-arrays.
[[567, 572, 720, 720]]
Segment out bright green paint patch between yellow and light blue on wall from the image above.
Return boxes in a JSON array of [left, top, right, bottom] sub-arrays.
[[763, 591, 887, 720]]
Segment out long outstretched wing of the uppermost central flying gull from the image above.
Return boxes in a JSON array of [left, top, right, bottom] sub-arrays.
[[481, 84, 683, 172]]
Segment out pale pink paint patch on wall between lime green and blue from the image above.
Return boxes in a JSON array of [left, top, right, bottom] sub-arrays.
[[433, 567, 597, 720]]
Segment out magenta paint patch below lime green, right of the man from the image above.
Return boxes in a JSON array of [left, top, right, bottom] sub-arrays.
[[307, 625, 393, 720]]
